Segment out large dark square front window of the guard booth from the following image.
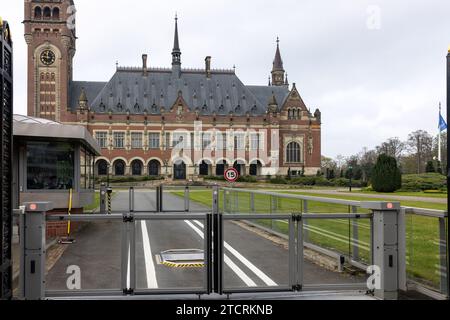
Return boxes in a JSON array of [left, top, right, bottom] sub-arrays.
[[27, 142, 74, 190]]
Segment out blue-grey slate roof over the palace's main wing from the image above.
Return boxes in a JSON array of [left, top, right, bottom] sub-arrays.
[[70, 68, 289, 115]]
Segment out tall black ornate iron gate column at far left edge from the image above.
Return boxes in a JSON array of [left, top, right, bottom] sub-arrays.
[[0, 18, 13, 300]]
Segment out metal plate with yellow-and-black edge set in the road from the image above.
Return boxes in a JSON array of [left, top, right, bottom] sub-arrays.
[[159, 249, 205, 268]]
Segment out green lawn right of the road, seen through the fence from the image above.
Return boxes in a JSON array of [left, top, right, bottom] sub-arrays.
[[173, 190, 447, 289]]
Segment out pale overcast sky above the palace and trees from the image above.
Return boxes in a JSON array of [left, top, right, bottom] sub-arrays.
[[0, 0, 450, 157]]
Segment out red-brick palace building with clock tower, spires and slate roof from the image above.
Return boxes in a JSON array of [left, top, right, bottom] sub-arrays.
[[24, 0, 321, 180]]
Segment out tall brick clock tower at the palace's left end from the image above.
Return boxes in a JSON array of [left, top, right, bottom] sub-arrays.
[[23, 0, 76, 122]]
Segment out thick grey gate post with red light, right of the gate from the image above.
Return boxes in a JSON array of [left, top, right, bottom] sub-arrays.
[[361, 202, 405, 300]]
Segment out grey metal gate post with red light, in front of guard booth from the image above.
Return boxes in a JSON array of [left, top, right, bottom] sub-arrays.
[[20, 202, 53, 300]]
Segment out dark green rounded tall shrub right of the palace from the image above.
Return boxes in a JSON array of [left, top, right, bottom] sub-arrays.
[[372, 154, 402, 192]]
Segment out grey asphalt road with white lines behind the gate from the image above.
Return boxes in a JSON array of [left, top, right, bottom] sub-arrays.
[[46, 190, 365, 290]]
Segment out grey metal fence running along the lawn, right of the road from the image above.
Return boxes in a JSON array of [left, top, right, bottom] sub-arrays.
[[221, 188, 449, 299]]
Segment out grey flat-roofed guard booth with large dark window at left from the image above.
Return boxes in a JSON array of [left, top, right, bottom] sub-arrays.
[[13, 115, 100, 238]]
